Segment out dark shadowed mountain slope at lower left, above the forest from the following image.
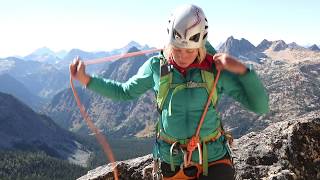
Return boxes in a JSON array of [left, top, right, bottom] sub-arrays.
[[0, 93, 91, 166]]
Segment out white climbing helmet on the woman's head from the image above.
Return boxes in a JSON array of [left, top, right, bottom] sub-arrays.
[[167, 4, 208, 49]]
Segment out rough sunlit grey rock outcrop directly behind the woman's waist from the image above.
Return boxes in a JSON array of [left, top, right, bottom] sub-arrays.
[[79, 112, 320, 180]]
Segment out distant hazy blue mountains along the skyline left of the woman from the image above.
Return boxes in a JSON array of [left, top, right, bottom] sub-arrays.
[[0, 41, 149, 102]]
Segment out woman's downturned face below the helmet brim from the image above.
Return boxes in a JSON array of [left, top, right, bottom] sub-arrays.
[[172, 47, 199, 68]]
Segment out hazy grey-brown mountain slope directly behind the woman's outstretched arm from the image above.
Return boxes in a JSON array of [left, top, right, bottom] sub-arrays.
[[44, 47, 157, 137]]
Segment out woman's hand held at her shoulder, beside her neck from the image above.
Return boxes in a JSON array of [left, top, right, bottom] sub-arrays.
[[213, 53, 247, 75]]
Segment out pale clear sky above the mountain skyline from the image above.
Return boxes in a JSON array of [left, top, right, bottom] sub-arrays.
[[0, 0, 320, 57]]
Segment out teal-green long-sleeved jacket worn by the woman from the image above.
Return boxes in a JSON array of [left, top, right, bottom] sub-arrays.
[[87, 44, 269, 165]]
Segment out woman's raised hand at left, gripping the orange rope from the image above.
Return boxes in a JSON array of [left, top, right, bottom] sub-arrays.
[[69, 56, 91, 86]]
